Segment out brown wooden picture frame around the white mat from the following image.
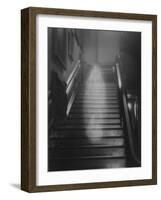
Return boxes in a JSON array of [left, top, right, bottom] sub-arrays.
[[21, 7, 157, 192]]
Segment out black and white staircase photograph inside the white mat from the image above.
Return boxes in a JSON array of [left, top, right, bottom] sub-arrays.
[[47, 27, 142, 171]]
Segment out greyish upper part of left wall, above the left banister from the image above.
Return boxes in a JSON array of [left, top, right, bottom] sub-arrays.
[[48, 28, 81, 85]]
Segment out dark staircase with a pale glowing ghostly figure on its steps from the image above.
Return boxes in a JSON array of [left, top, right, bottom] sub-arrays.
[[48, 66, 127, 171]]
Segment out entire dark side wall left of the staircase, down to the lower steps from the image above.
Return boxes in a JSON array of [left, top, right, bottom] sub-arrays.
[[48, 28, 81, 126]]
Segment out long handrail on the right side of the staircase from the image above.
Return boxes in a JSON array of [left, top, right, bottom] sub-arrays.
[[116, 63, 140, 165]]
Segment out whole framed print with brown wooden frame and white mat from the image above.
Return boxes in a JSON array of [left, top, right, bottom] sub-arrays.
[[21, 7, 157, 192]]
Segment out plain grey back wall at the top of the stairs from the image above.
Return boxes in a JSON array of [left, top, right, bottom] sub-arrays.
[[83, 30, 120, 65]]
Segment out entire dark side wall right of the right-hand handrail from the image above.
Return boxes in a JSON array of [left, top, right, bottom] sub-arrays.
[[120, 32, 141, 160]]
